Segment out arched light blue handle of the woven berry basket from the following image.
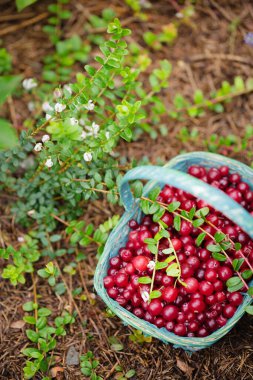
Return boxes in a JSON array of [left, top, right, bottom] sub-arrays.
[[119, 165, 253, 238]]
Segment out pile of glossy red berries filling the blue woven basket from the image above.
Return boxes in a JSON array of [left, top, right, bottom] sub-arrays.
[[104, 166, 253, 337]]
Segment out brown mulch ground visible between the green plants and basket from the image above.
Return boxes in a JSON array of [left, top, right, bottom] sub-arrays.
[[0, 0, 253, 380]]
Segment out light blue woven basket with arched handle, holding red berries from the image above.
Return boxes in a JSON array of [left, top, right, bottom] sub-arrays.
[[94, 152, 253, 351]]
